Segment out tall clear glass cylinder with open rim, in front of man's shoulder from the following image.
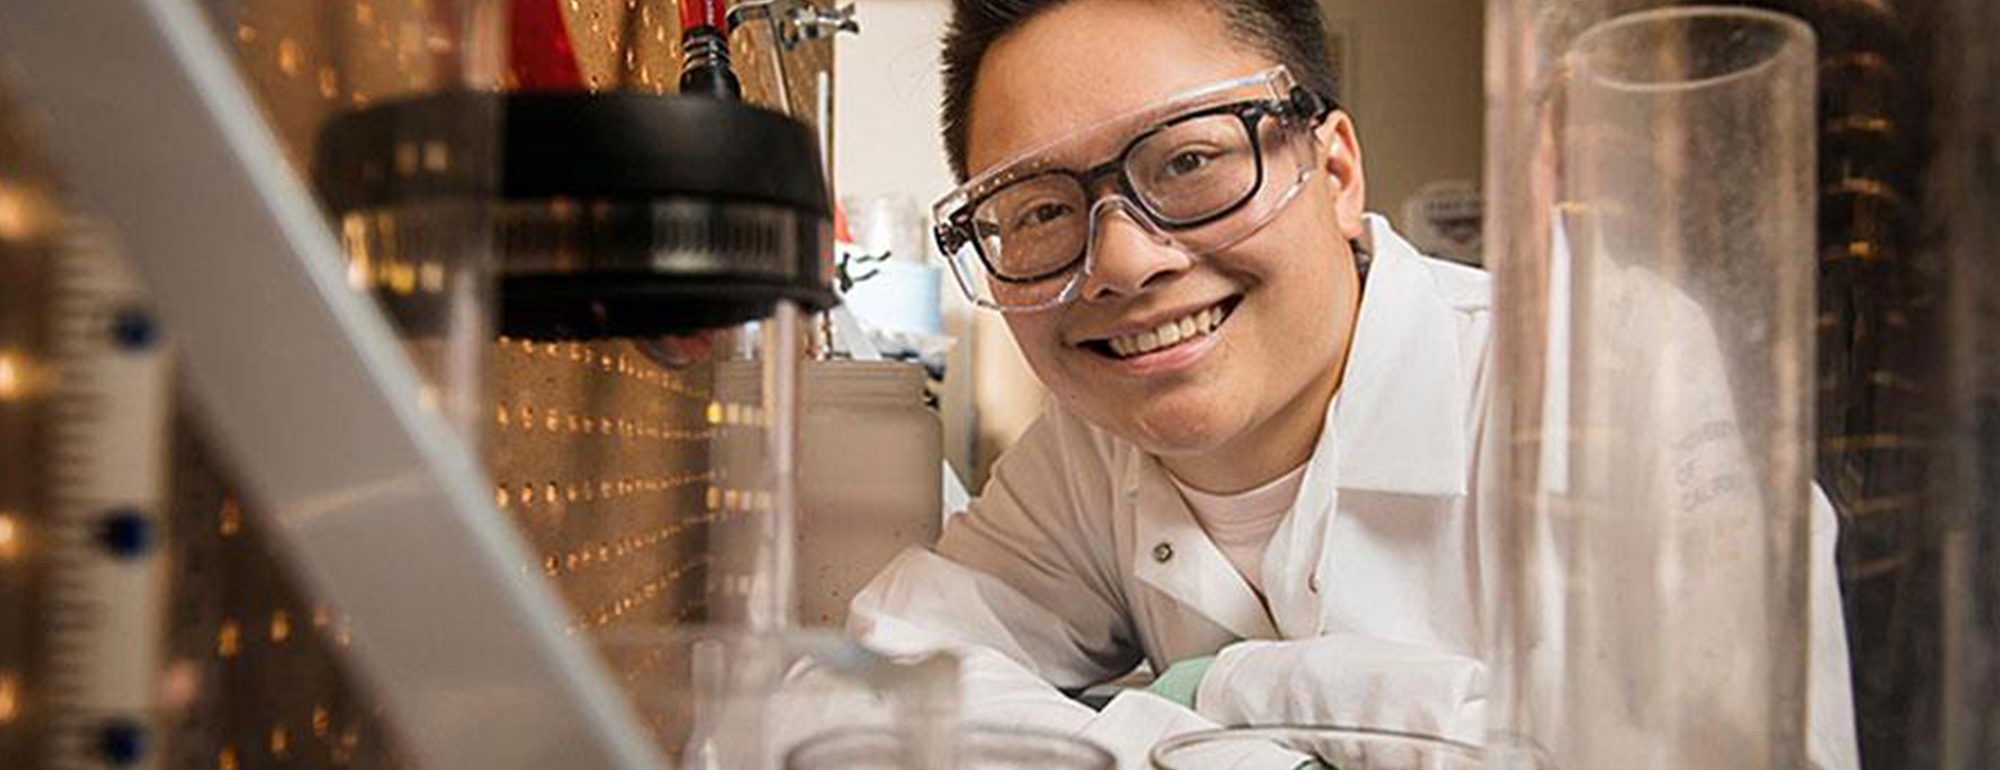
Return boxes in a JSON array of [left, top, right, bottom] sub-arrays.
[[1488, 0, 1816, 770]]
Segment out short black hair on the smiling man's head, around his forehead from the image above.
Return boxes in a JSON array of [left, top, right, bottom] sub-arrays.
[[940, 0, 1340, 182]]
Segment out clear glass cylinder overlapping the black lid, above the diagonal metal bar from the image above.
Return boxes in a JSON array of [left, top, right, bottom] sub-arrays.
[[204, 0, 506, 446]]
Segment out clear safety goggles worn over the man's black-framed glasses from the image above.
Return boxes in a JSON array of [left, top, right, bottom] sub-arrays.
[[932, 66, 1334, 310]]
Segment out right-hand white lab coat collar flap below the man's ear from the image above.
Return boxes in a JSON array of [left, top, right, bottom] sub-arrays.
[[1316, 214, 1472, 496]]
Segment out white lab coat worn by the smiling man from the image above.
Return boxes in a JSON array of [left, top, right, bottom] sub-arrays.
[[850, 218, 1856, 770]]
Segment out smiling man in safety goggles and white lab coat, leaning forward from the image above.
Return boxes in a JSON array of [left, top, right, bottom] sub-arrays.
[[850, 0, 1852, 768]]
